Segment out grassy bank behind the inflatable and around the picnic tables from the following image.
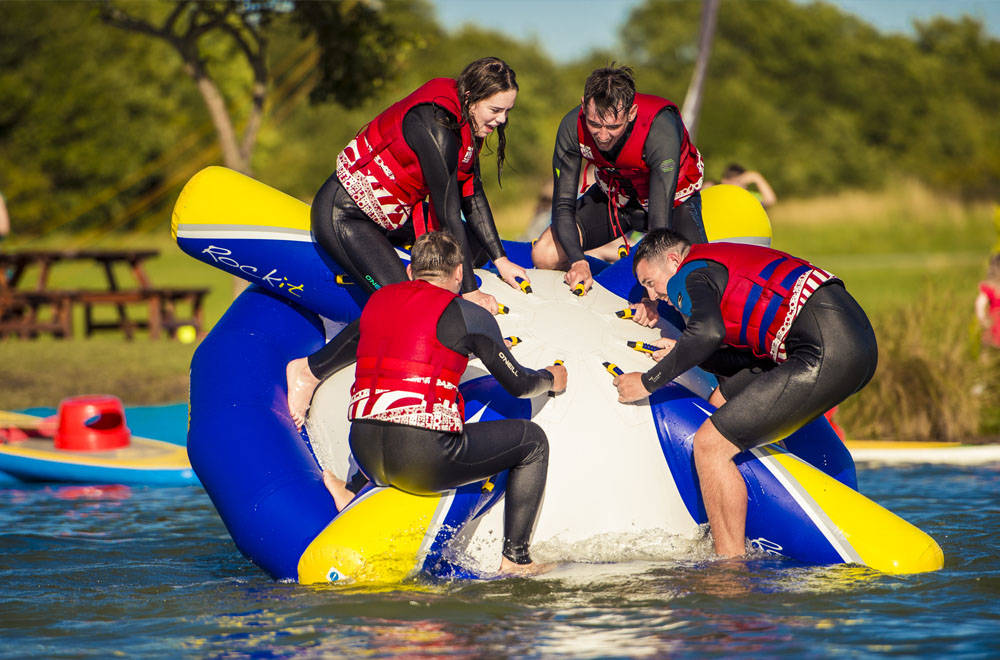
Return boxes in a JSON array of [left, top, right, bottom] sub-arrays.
[[0, 184, 1000, 439]]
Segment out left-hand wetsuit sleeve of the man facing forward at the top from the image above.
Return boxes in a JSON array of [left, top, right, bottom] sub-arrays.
[[552, 106, 584, 263]]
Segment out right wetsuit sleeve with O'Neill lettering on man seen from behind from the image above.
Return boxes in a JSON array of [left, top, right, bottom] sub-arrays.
[[437, 298, 553, 398]]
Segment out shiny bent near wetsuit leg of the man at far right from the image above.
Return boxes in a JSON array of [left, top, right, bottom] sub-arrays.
[[712, 282, 878, 449]]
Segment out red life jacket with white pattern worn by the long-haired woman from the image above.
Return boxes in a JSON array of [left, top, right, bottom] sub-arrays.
[[337, 78, 477, 236]]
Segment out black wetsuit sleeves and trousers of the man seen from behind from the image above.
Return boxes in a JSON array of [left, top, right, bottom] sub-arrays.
[[309, 298, 552, 564]]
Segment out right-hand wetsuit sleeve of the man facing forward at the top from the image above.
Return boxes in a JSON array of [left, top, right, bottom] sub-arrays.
[[643, 107, 684, 237]]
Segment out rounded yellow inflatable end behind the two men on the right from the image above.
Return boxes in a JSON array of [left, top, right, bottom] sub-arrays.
[[701, 184, 771, 247]]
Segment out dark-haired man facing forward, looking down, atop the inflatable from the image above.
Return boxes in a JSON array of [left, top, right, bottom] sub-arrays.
[[531, 63, 707, 295]]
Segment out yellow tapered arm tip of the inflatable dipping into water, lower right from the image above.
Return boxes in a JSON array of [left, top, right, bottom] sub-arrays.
[[761, 446, 944, 574]]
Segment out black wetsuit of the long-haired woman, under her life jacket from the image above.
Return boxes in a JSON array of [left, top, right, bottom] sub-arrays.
[[312, 103, 504, 294]]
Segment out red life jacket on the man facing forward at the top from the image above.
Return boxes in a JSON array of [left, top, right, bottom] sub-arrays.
[[576, 94, 705, 208]]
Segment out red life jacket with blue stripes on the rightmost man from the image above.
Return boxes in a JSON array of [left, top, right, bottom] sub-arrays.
[[668, 243, 834, 362]]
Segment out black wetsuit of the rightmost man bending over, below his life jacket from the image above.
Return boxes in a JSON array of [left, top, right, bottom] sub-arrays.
[[642, 261, 878, 449]]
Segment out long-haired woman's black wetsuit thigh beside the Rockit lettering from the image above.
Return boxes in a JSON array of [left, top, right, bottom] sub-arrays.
[[311, 173, 407, 295]]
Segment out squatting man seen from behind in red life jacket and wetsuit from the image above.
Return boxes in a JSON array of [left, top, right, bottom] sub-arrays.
[[288, 232, 567, 575]]
